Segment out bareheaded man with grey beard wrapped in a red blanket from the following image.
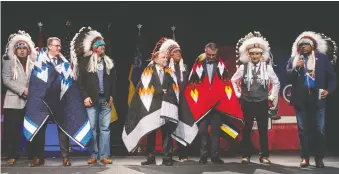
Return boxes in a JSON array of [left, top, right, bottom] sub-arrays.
[[185, 43, 243, 164]]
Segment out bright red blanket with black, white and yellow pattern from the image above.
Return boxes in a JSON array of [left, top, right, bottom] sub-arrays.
[[184, 54, 244, 138]]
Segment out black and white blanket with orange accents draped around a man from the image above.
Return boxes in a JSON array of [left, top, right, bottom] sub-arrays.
[[122, 64, 198, 152]]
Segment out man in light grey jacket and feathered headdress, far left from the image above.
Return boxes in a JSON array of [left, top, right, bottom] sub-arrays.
[[2, 30, 37, 165]]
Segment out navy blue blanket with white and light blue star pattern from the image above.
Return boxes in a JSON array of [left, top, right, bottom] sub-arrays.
[[23, 50, 92, 147]]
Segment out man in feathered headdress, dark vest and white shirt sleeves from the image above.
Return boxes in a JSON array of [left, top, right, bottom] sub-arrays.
[[231, 32, 280, 164]]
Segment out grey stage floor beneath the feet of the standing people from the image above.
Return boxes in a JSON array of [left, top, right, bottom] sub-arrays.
[[1, 154, 339, 174]]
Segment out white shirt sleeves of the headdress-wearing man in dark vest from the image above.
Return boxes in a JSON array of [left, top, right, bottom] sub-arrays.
[[231, 65, 280, 101]]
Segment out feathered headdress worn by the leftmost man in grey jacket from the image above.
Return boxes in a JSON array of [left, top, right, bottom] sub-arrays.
[[3, 30, 37, 80]]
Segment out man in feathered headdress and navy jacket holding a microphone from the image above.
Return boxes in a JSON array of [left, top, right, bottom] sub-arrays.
[[286, 31, 337, 168]]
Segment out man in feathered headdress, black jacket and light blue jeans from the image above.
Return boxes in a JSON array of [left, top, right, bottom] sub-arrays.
[[70, 27, 116, 164]]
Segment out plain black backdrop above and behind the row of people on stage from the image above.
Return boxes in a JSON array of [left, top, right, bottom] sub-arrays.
[[1, 1, 339, 152]]
